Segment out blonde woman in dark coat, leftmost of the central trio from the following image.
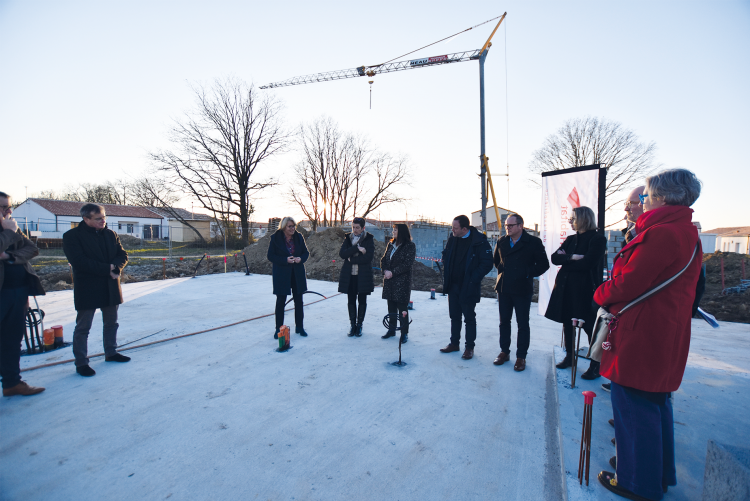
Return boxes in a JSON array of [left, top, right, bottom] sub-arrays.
[[266, 217, 310, 339]]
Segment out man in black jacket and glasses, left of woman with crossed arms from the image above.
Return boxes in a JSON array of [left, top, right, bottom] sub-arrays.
[[493, 214, 549, 372]]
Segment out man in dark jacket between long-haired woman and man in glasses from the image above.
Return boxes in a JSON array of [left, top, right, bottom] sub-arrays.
[[440, 215, 492, 360]]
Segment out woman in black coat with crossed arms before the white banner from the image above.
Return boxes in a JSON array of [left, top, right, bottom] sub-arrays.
[[544, 207, 607, 379]]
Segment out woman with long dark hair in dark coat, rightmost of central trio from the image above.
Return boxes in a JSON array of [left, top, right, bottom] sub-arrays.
[[380, 224, 417, 343]]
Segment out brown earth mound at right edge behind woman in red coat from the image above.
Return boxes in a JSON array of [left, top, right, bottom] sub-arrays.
[[700, 251, 750, 323]]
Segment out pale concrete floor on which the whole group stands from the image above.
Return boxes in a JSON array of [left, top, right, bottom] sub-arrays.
[[0, 273, 750, 500]]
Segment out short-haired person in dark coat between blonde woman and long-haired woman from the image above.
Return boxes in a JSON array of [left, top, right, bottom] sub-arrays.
[[339, 217, 375, 337]]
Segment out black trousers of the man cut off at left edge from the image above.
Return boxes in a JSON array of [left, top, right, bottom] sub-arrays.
[[0, 288, 29, 388]]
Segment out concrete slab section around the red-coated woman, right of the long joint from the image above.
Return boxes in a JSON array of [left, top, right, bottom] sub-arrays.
[[554, 320, 750, 501]]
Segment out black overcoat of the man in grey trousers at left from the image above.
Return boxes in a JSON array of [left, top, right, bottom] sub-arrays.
[[63, 221, 128, 310]]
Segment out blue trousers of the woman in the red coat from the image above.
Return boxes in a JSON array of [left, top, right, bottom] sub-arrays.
[[611, 382, 677, 500]]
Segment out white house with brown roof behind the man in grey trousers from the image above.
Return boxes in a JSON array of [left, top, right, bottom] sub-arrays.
[[13, 198, 164, 238]]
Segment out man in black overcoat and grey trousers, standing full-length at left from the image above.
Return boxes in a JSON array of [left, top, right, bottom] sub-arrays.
[[63, 204, 130, 377]]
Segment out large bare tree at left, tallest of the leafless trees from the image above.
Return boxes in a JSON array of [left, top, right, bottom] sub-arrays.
[[150, 79, 291, 244]]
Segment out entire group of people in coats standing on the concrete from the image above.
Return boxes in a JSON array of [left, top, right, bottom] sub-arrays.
[[0, 169, 705, 500]]
